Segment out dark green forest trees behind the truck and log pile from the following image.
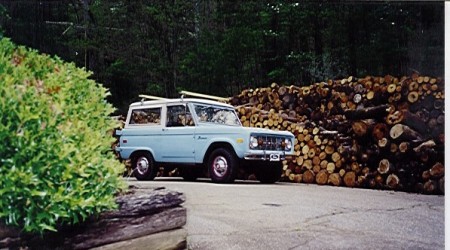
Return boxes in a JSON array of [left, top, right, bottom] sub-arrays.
[[0, 0, 444, 114]]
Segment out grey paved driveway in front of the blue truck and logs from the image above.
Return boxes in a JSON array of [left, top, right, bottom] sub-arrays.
[[129, 178, 445, 249]]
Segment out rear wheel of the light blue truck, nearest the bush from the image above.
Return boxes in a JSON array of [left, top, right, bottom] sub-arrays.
[[131, 152, 158, 181]]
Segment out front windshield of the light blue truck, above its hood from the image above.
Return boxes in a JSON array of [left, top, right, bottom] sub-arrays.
[[194, 104, 241, 126]]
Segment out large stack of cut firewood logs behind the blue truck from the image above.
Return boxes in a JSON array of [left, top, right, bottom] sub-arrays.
[[229, 74, 445, 194]]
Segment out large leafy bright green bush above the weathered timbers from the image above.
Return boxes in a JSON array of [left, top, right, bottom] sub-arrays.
[[0, 38, 124, 233]]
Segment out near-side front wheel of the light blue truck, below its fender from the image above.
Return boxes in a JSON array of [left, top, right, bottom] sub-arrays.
[[207, 148, 239, 183]]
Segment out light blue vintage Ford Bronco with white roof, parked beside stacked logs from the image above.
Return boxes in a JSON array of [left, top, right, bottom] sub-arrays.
[[116, 98, 294, 183]]
